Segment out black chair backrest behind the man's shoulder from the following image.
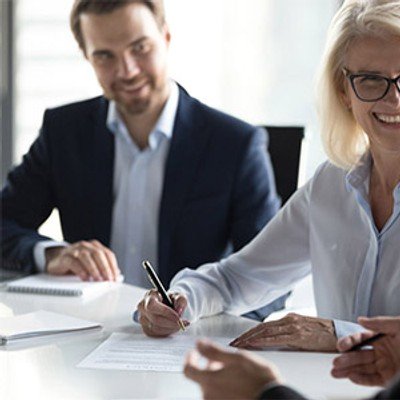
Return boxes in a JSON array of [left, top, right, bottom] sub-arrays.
[[263, 126, 304, 205]]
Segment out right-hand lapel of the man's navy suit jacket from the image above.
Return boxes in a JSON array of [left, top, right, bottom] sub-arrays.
[[158, 88, 209, 282]]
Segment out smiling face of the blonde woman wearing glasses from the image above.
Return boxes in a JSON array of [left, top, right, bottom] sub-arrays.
[[344, 36, 400, 155]]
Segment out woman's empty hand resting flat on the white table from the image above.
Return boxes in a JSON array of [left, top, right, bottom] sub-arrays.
[[231, 313, 337, 351]]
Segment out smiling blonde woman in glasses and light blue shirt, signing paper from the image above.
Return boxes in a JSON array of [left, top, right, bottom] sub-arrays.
[[138, 0, 400, 351]]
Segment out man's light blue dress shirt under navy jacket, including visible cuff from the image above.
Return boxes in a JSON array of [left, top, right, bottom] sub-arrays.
[[34, 81, 179, 288]]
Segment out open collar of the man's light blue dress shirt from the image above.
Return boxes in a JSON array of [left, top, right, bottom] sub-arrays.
[[106, 80, 179, 148]]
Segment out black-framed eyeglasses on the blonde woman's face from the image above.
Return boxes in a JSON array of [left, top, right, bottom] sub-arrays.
[[343, 68, 400, 101]]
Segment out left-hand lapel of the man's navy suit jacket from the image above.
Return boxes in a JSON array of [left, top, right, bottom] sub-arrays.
[[87, 97, 114, 246]]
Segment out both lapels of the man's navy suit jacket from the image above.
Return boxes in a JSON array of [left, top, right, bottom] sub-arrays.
[[80, 88, 209, 272]]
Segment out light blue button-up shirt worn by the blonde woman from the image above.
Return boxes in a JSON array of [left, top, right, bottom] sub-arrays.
[[171, 154, 400, 337]]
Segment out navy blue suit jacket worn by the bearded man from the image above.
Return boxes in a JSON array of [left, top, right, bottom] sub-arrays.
[[1, 88, 280, 290]]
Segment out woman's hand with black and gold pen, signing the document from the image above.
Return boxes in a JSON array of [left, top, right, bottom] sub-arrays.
[[137, 261, 189, 337]]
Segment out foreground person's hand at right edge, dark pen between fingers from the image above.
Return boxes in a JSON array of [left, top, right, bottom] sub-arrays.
[[332, 317, 400, 386]]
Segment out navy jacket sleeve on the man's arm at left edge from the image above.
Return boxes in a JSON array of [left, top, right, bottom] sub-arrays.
[[0, 114, 55, 272]]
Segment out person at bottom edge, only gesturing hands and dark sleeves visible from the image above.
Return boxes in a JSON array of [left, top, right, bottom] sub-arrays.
[[184, 317, 400, 399]]
